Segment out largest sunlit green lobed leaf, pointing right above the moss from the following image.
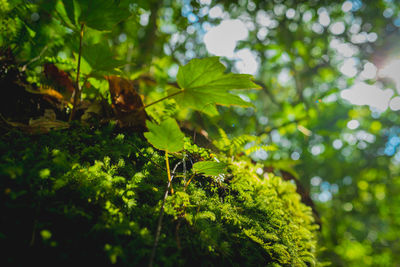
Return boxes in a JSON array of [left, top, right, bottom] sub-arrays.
[[170, 57, 260, 115]]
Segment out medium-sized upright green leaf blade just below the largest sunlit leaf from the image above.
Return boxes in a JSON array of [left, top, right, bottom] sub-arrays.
[[144, 118, 185, 152]]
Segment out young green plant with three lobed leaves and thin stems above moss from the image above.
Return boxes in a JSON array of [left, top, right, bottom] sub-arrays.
[[144, 57, 258, 266]]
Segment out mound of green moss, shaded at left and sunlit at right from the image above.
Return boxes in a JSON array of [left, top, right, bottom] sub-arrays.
[[0, 126, 317, 266]]
